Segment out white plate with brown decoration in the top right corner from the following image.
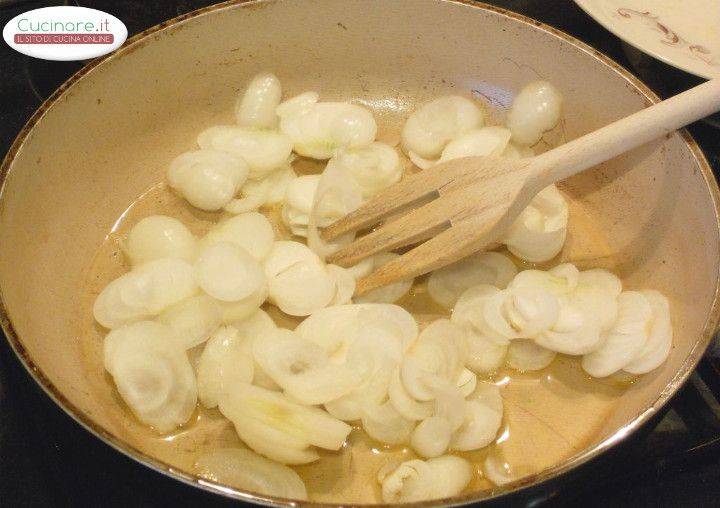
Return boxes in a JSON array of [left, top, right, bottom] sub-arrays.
[[575, 0, 720, 78]]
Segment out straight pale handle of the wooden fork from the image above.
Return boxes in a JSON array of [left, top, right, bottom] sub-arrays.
[[530, 78, 720, 188]]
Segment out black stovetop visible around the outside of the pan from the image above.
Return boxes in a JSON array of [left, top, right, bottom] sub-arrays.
[[0, 0, 720, 507]]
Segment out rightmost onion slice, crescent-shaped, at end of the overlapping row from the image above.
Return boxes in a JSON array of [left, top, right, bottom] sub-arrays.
[[623, 290, 673, 374]]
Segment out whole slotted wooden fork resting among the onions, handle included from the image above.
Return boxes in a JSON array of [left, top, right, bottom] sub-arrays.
[[321, 78, 720, 295]]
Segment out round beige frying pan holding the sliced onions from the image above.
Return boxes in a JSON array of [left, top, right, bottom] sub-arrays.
[[0, 0, 720, 505]]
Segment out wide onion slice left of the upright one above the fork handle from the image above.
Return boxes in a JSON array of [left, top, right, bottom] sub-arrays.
[[402, 95, 484, 159]]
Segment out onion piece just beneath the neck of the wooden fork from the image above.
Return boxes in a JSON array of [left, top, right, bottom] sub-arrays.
[[503, 185, 569, 263]]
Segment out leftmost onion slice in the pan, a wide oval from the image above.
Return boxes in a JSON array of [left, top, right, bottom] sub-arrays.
[[93, 258, 198, 328]]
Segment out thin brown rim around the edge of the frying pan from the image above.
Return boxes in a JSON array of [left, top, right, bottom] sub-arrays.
[[0, 0, 720, 507]]
